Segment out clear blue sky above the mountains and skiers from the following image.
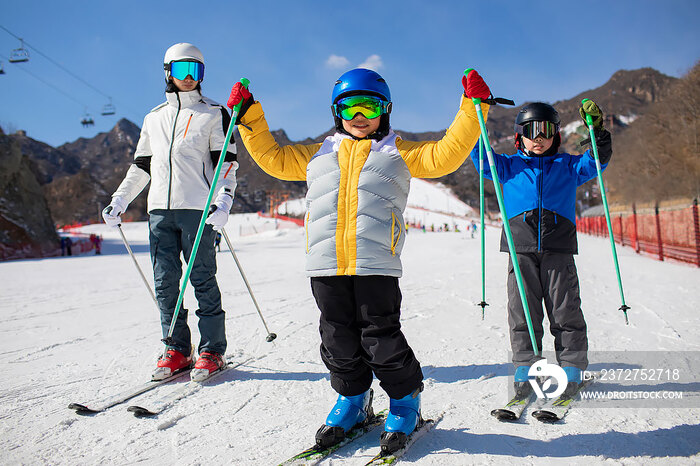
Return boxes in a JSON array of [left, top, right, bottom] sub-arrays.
[[0, 0, 700, 146]]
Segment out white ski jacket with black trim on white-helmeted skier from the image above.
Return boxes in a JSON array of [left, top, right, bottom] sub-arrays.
[[112, 90, 238, 212]]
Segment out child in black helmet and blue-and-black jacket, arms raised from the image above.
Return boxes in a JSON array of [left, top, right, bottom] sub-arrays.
[[471, 100, 612, 394]]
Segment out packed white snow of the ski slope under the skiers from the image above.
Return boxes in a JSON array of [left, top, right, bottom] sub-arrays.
[[0, 180, 700, 465]]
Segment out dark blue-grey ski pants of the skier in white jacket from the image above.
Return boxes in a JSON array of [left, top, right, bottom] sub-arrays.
[[148, 209, 226, 355]]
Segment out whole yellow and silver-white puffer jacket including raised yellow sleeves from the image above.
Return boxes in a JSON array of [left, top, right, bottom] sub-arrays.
[[238, 97, 488, 277]]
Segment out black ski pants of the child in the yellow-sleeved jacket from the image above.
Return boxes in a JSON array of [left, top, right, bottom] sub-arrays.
[[311, 275, 423, 399]]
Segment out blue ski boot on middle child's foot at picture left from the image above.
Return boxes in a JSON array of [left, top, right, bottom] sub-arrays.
[[316, 388, 374, 449]]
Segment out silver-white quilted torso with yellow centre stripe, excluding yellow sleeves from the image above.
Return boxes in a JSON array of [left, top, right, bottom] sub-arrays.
[[306, 132, 411, 277]]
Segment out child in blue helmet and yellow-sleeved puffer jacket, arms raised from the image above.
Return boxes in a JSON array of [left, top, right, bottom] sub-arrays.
[[228, 68, 490, 451]]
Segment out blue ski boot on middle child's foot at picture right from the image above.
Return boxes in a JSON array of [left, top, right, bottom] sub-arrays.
[[379, 387, 423, 454]]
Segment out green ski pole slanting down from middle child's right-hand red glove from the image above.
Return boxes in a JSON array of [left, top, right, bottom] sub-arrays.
[[464, 68, 540, 356]]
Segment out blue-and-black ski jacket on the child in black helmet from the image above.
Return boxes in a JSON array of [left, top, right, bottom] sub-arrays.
[[471, 130, 612, 254]]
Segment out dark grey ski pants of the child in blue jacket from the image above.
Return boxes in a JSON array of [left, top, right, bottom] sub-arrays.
[[508, 252, 588, 370]]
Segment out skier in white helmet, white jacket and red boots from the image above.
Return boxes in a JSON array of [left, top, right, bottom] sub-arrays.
[[102, 43, 238, 380]]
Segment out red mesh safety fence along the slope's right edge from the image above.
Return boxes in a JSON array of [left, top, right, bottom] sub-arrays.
[[576, 199, 700, 267]]
